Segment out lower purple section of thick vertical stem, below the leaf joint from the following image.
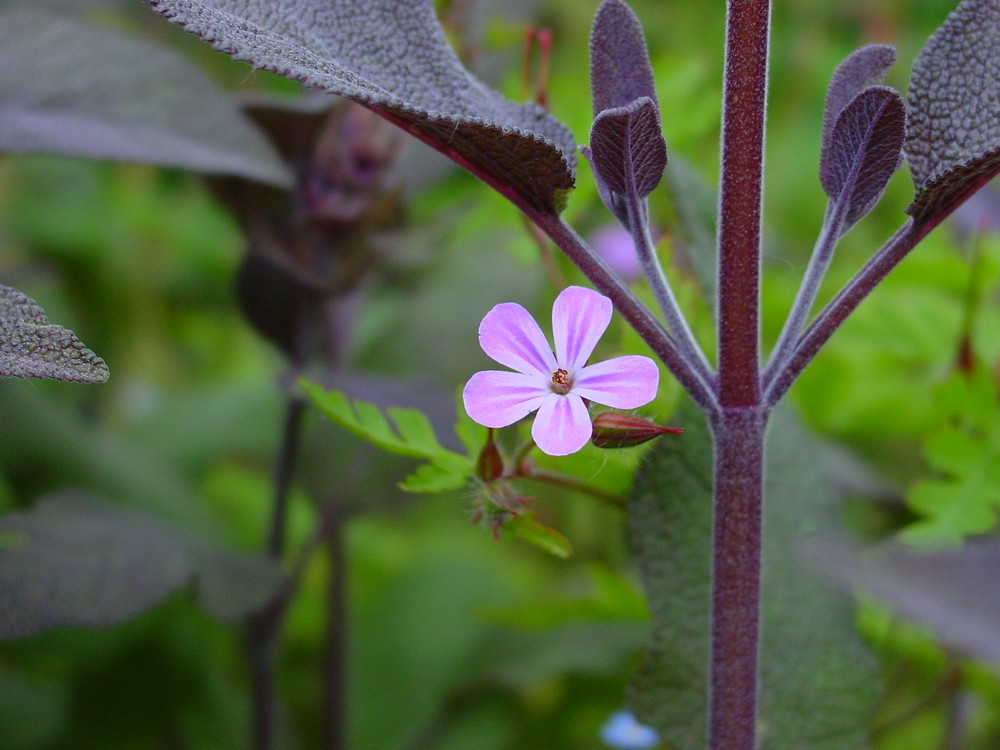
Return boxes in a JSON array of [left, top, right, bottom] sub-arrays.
[[709, 407, 767, 750]]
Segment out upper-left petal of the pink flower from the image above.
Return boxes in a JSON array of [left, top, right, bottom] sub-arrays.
[[479, 302, 556, 378]]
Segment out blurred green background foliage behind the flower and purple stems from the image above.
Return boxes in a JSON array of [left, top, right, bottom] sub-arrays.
[[0, 0, 1000, 750]]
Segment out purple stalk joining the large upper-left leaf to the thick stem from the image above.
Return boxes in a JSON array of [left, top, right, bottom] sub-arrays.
[[529, 212, 718, 413]]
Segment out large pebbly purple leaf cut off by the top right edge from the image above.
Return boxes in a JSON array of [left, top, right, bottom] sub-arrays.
[[904, 0, 1000, 225]]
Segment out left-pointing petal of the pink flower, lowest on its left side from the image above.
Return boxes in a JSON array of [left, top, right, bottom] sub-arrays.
[[462, 370, 554, 427]]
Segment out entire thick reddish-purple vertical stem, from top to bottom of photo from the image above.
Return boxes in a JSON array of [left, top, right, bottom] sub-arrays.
[[709, 0, 770, 750]]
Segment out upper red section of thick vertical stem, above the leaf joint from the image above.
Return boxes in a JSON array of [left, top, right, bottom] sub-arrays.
[[719, 0, 771, 407]]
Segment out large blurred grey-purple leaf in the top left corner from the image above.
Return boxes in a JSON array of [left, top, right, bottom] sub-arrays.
[[0, 9, 291, 186]]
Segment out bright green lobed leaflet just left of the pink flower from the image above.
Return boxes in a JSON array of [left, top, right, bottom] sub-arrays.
[[299, 379, 475, 492]]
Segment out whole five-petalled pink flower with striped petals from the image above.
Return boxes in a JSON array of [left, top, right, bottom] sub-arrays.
[[462, 286, 660, 456]]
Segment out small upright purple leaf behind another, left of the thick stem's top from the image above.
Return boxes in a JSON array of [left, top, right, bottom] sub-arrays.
[[590, 0, 656, 117]]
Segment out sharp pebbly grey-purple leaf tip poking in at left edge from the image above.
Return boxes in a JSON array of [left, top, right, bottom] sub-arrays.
[[0, 286, 109, 383]]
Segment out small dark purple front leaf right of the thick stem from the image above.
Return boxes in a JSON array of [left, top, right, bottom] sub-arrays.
[[820, 86, 906, 231]]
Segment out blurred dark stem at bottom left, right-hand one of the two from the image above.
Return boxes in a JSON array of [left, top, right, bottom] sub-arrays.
[[323, 500, 348, 750]]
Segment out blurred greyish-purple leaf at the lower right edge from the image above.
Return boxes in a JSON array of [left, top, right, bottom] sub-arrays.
[[804, 536, 1000, 662]]
